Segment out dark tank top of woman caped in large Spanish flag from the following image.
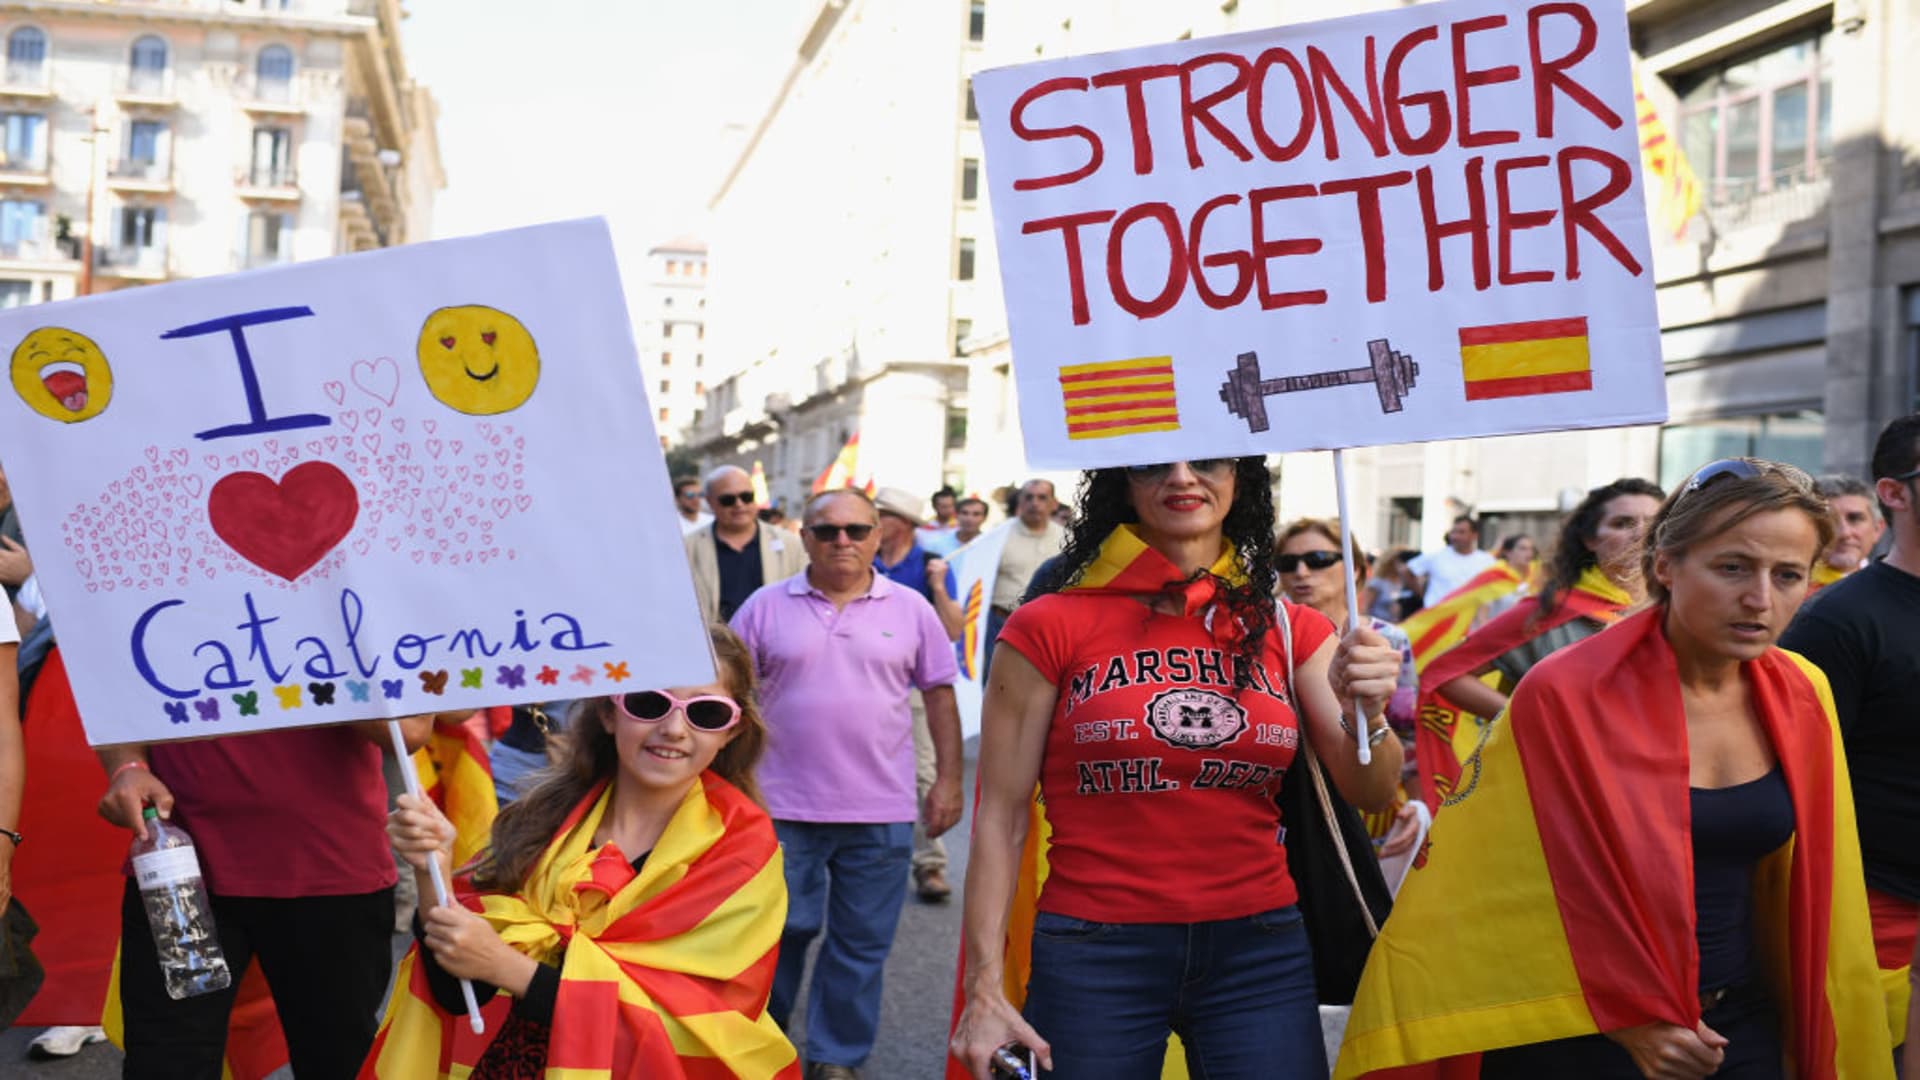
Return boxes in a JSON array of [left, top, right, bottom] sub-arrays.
[[1692, 765, 1793, 990]]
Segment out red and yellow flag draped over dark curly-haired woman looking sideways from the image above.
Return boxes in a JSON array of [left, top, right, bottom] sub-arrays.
[[1413, 567, 1634, 813]]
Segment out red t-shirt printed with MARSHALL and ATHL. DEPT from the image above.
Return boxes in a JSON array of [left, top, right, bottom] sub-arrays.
[[1000, 592, 1334, 922]]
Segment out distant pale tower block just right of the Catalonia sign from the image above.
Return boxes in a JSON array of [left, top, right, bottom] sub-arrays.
[[634, 236, 707, 450]]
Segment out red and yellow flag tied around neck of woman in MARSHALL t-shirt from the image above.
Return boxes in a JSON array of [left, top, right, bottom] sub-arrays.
[[945, 525, 1246, 1080]]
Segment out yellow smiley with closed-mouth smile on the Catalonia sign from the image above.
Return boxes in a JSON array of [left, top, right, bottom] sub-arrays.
[[419, 304, 540, 417]]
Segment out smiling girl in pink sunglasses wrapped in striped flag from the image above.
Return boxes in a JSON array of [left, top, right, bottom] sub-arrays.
[[363, 625, 799, 1080]]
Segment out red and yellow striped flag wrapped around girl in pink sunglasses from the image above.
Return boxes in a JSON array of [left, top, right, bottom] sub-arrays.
[[361, 773, 801, 1080]]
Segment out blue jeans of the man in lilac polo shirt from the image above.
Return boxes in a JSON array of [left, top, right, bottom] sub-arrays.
[[766, 821, 914, 1068]]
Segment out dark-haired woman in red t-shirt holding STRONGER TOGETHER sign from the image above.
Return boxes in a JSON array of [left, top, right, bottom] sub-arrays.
[[952, 457, 1400, 1080]]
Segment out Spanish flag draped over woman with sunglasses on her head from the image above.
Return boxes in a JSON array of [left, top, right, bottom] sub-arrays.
[[1334, 607, 1893, 1080]]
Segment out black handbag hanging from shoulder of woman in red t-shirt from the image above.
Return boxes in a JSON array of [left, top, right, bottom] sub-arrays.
[[1277, 609, 1394, 1005]]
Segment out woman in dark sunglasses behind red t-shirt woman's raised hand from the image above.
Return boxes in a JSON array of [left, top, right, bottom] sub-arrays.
[[1273, 517, 1421, 857]]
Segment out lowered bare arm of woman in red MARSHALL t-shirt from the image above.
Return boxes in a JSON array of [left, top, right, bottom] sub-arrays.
[[952, 646, 1060, 1080]]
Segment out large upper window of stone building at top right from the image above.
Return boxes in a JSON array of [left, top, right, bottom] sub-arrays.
[[1678, 31, 1834, 206]]
